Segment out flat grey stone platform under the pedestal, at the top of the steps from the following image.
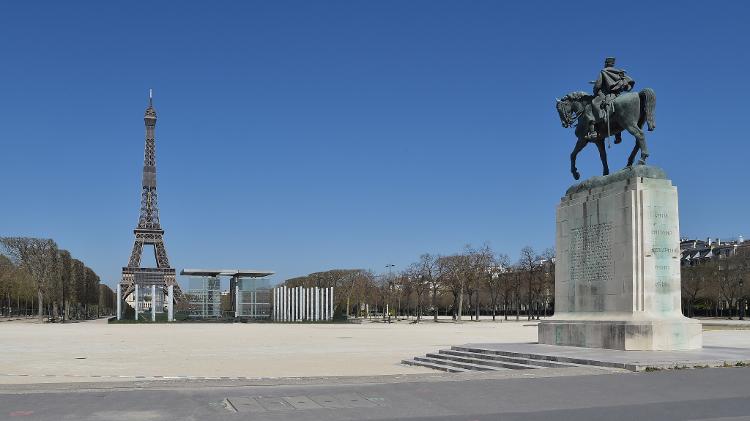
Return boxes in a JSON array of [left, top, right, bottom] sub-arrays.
[[464, 343, 750, 371]]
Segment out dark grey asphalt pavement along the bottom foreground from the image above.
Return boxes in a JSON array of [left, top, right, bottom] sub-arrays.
[[0, 368, 750, 421]]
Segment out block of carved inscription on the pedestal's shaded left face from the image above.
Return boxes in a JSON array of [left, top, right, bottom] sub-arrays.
[[570, 222, 612, 283]]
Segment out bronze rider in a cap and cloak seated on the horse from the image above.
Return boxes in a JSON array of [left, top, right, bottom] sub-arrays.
[[586, 57, 635, 139]]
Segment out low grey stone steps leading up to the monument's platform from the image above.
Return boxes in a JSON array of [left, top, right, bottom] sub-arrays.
[[402, 346, 578, 373]]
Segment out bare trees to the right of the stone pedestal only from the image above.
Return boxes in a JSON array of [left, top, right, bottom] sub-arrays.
[[682, 254, 750, 318]]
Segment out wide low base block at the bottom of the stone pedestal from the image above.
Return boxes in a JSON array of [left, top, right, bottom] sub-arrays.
[[538, 318, 703, 351]]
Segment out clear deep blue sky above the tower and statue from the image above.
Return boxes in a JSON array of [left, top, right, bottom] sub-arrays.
[[0, 0, 750, 284]]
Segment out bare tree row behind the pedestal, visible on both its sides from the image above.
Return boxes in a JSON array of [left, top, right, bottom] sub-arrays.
[[286, 246, 750, 320]]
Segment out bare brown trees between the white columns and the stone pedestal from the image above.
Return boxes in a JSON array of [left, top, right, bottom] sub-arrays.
[[285, 245, 555, 320]]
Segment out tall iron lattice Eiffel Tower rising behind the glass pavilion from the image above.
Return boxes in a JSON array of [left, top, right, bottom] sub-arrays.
[[121, 90, 182, 303]]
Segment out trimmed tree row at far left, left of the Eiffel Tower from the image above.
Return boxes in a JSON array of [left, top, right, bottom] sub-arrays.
[[0, 237, 116, 321]]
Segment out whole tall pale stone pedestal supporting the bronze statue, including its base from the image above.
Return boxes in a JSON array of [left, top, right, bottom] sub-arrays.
[[538, 166, 702, 350]]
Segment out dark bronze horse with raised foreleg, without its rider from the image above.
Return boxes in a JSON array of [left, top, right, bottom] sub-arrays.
[[557, 88, 656, 180]]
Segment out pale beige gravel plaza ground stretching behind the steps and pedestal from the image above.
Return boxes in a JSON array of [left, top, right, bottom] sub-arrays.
[[0, 318, 750, 384]]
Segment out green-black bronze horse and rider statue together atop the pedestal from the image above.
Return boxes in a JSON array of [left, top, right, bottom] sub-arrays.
[[557, 57, 656, 180]]
